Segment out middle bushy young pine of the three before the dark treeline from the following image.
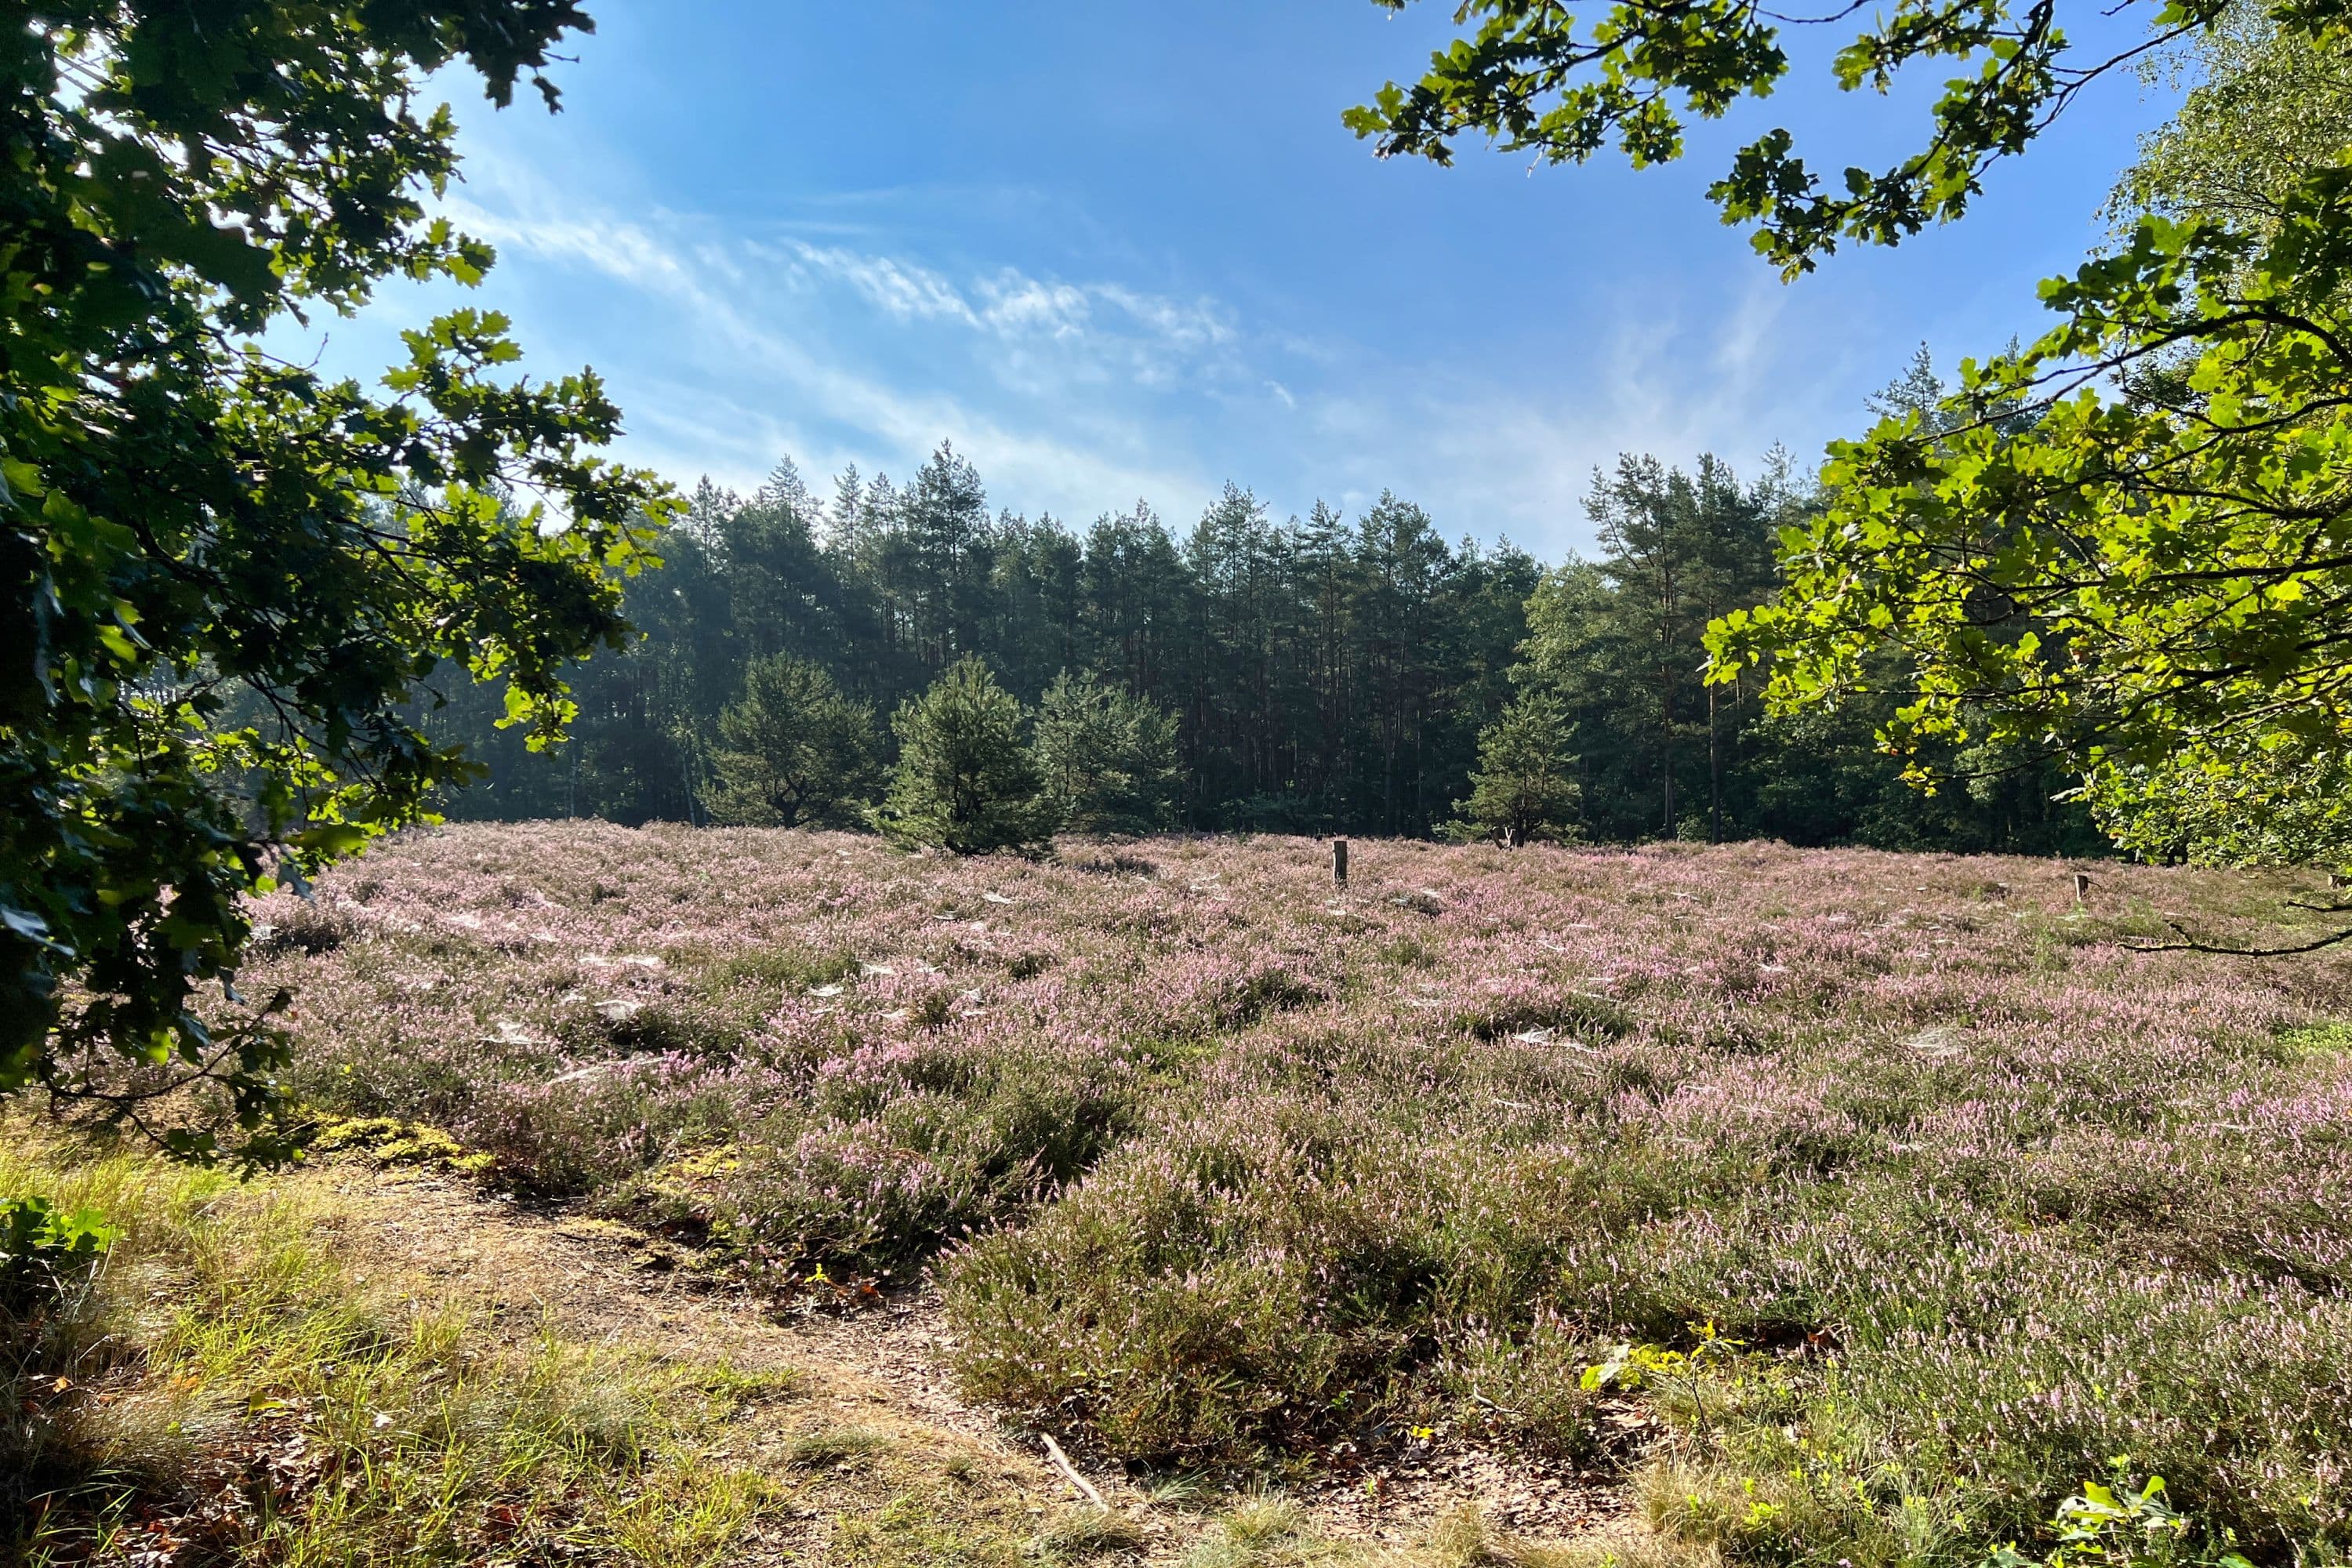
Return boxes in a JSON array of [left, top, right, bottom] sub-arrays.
[[873, 659, 1058, 855]]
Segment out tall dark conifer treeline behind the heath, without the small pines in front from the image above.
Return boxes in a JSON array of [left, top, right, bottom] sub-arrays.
[[430, 447, 2096, 851]]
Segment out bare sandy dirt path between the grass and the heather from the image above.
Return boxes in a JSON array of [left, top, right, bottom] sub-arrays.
[[310, 1163, 1625, 1559]]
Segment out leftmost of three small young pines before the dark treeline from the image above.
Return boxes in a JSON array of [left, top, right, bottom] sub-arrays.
[[713, 654, 877, 827]]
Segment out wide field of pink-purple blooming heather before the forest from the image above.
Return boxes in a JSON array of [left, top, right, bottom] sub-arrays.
[[247, 822, 2352, 1566]]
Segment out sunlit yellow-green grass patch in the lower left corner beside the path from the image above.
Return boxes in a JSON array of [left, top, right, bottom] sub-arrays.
[[0, 1126, 1054, 1568]]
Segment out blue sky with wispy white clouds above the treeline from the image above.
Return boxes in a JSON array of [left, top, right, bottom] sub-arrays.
[[299, 0, 2166, 557]]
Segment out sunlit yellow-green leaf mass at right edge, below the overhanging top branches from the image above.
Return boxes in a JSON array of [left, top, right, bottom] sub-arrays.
[[1710, 165, 2352, 869]]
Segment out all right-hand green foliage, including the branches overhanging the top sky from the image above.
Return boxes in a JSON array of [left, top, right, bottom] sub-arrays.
[[1348, 0, 2352, 860]]
